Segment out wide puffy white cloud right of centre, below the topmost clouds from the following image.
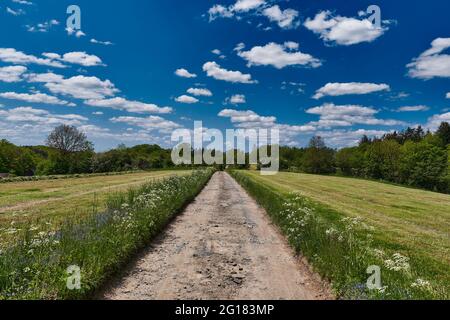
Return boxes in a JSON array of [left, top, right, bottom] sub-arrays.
[[238, 41, 321, 69]]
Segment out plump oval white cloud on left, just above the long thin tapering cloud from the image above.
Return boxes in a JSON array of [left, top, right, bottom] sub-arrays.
[[45, 76, 119, 99]]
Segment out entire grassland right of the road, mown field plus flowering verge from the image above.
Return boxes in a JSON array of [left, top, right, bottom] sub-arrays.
[[231, 170, 450, 299]]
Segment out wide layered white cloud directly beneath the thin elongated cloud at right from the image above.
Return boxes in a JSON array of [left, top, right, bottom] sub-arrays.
[[306, 103, 404, 128]]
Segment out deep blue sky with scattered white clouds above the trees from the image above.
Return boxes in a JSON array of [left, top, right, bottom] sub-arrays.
[[0, 0, 450, 150]]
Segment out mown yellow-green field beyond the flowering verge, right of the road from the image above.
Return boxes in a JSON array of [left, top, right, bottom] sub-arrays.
[[239, 171, 450, 298]]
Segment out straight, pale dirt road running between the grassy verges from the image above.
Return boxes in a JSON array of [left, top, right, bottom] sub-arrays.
[[100, 172, 332, 300]]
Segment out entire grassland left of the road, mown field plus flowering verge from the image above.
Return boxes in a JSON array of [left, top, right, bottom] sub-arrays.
[[0, 169, 213, 300]]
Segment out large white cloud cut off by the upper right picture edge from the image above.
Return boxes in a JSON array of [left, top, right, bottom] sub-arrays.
[[407, 38, 450, 79]]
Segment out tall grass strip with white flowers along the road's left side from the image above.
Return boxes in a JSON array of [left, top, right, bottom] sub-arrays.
[[0, 169, 212, 299]]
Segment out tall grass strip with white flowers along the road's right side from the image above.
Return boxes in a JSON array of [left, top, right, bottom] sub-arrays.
[[230, 171, 450, 299]]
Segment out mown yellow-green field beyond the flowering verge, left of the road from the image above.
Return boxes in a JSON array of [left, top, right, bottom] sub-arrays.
[[0, 170, 190, 240]]
